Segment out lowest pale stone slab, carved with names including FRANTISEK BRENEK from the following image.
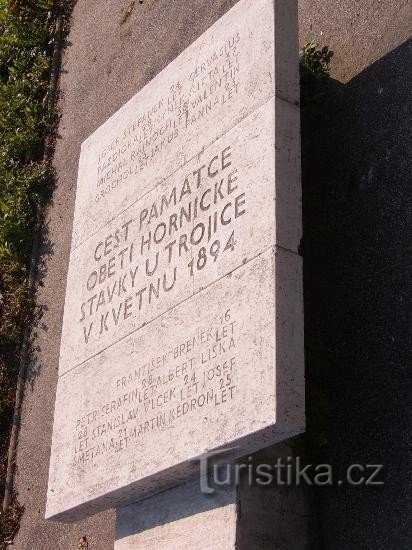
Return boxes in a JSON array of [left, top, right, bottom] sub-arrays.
[[47, 247, 304, 520]]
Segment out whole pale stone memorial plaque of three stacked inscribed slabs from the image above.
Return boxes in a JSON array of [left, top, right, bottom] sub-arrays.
[[46, 0, 304, 521]]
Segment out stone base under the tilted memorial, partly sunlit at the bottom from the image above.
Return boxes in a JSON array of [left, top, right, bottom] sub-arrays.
[[114, 445, 308, 550]]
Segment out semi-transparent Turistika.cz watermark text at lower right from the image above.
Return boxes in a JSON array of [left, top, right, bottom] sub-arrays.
[[198, 453, 384, 494]]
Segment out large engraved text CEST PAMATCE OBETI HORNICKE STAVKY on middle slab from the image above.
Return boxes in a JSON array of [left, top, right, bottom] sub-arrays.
[[78, 146, 246, 350]]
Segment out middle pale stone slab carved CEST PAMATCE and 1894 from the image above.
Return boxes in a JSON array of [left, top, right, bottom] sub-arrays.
[[60, 99, 300, 374]]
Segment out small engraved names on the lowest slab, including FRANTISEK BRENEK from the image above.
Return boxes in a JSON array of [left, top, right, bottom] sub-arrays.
[[72, 309, 238, 465]]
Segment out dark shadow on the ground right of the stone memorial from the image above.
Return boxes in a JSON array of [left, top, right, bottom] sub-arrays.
[[302, 41, 412, 550]]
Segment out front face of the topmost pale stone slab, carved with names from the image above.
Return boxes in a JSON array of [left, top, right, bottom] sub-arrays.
[[73, 0, 275, 247]]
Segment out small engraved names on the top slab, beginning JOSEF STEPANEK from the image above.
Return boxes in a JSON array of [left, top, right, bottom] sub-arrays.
[[95, 33, 241, 207]]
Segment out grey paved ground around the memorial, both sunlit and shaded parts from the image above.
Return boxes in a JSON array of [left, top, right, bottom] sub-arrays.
[[15, 0, 411, 550]]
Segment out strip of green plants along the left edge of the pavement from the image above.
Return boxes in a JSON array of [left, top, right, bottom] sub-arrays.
[[0, 0, 55, 548]]
